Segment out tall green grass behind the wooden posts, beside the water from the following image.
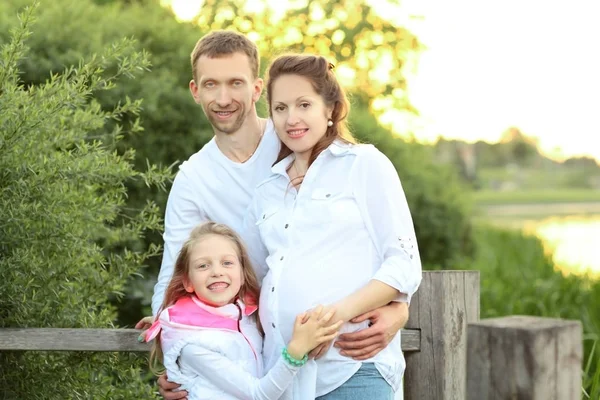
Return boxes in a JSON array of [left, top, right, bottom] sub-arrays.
[[459, 224, 600, 400]]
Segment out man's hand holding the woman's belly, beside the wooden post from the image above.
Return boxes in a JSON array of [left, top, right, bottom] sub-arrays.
[[332, 302, 408, 361]]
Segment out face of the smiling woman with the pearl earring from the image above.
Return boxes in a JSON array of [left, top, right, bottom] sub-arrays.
[[270, 75, 332, 159]]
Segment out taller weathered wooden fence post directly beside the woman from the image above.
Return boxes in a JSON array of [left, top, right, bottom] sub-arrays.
[[404, 271, 479, 400]]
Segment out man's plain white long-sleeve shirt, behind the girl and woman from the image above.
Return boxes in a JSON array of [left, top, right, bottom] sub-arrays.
[[152, 120, 280, 315]]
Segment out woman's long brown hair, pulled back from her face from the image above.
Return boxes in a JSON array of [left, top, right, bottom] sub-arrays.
[[267, 54, 356, 166]]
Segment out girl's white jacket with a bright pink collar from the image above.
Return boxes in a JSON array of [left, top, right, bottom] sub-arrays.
[[146, 296, 299, 400]]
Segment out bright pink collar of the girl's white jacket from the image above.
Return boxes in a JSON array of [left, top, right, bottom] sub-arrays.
[[146, 295, 258, 342]]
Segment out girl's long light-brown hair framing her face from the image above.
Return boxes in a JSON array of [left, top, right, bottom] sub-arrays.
[[150, 222, 260, 375]]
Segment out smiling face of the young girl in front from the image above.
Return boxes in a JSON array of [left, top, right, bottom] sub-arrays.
[[185, 235, 243, 307]]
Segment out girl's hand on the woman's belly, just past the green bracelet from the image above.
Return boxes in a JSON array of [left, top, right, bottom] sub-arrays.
[[287, 306, 344, 360]]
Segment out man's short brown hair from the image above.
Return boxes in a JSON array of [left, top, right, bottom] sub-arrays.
[[192, 30, 260, 83]]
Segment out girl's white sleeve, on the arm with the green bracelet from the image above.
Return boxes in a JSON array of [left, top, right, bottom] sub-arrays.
[[180, 344, 300, 400]]
